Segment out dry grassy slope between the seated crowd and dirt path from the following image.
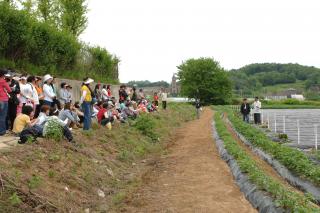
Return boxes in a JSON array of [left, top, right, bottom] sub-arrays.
[[0, 104, 195, 212]]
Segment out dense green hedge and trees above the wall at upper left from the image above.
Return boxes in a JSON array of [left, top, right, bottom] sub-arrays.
[[0, 0, 119, 83]]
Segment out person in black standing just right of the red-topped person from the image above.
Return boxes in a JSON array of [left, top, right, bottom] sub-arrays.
[[5, 73, 20, 130]]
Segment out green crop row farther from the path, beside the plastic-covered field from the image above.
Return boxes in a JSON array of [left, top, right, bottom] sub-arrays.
[[222, 106, 320, 186]]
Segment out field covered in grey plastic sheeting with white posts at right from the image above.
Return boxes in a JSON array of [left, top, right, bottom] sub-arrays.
[[262, 109, 320, 147]]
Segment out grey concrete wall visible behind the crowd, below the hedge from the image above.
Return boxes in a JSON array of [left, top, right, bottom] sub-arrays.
[[56, 78, 120, 101]]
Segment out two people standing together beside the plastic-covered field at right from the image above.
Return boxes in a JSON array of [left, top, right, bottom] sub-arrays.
[[240, 97, 261, 124]]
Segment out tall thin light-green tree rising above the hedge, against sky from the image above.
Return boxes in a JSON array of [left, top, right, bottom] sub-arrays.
[[59, 0, 88, 37]]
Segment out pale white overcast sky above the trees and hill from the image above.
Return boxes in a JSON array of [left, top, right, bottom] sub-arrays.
[[81, 0, 320, 82]]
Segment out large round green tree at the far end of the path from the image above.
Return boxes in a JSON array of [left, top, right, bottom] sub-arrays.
[[178, 58, 232, 104]]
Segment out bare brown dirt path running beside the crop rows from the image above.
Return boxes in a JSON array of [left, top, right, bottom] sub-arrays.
[[126, 109, 256, 213]]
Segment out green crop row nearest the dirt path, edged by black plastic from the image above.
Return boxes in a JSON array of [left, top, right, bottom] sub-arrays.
[[215, 113, 319, 212]]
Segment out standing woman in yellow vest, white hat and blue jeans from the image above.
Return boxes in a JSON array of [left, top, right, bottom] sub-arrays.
[[80, 78, 94, 130]]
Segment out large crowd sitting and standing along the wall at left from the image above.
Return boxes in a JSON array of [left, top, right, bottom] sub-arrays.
[[0, 69, 167, 142]]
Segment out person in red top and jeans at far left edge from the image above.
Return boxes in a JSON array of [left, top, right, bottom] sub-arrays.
[[0, 69, 11, 135]]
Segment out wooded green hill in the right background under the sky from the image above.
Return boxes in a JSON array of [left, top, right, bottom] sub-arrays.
[[229, 63, 320, 94]]
